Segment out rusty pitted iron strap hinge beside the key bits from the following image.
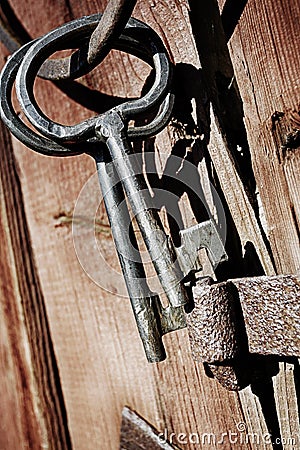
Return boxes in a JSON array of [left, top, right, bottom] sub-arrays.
[[187, 275, 300, 389]]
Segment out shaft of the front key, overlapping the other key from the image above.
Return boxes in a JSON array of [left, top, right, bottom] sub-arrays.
[[96, 110, 188, 307]]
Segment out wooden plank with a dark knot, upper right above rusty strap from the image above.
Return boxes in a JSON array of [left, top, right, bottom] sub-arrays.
[[229, 0, 300, 273]]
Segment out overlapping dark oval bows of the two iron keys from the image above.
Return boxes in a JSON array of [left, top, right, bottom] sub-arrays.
[[0, 14, 173, 156]]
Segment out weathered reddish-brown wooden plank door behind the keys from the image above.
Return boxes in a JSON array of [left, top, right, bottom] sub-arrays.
[[0, 0, 300, 450]]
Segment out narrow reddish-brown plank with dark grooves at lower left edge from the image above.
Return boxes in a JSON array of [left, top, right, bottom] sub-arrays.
[[0, 118, 70, 450]]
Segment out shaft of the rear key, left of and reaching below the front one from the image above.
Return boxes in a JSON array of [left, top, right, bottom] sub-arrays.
[[96, 152, 166, 362]]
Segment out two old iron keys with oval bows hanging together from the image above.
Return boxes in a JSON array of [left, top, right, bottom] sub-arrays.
[[0, 14, 227, 362]]
